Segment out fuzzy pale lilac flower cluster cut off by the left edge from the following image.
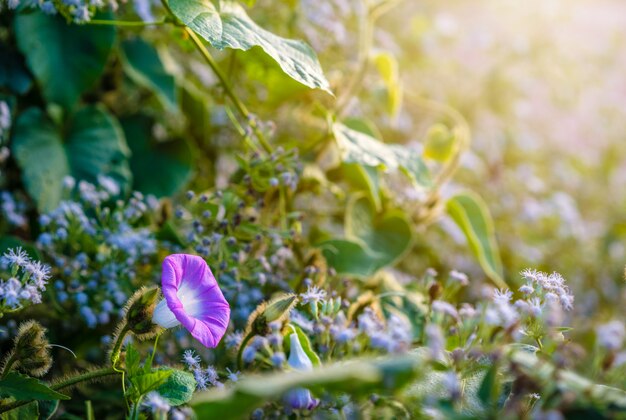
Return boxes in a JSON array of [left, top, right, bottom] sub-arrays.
[[0, 247, 50, 316]]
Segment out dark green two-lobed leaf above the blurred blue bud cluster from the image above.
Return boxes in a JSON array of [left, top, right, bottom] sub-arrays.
[[12, 107, 131, 211]]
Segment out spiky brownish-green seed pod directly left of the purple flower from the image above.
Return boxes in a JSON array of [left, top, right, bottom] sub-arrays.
[[124, 287, 160, 340]]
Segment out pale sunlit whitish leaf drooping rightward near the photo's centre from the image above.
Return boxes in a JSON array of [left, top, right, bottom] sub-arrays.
[[333, 123, 431, 188]]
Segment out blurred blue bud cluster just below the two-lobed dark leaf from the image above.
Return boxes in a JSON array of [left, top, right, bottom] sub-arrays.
[[37, 177, 158, 327]]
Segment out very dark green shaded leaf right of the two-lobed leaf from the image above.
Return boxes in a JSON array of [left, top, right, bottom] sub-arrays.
[[122, 115, 193, 197]]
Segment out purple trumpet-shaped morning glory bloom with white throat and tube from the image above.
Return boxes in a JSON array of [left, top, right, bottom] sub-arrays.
[[152, 254, 230, 348]]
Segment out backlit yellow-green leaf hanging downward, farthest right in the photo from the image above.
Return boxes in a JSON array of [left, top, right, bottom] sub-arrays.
[[446, 192, 508, 288]]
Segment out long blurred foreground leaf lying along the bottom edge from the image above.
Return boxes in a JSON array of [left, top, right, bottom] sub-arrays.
[[191, 354, 424, 419]]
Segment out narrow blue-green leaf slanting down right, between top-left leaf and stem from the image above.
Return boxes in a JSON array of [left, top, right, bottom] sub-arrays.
[[121, 38, 178, 112]]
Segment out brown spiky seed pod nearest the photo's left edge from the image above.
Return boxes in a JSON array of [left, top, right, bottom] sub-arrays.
[[13, 320, 52, 377]]
